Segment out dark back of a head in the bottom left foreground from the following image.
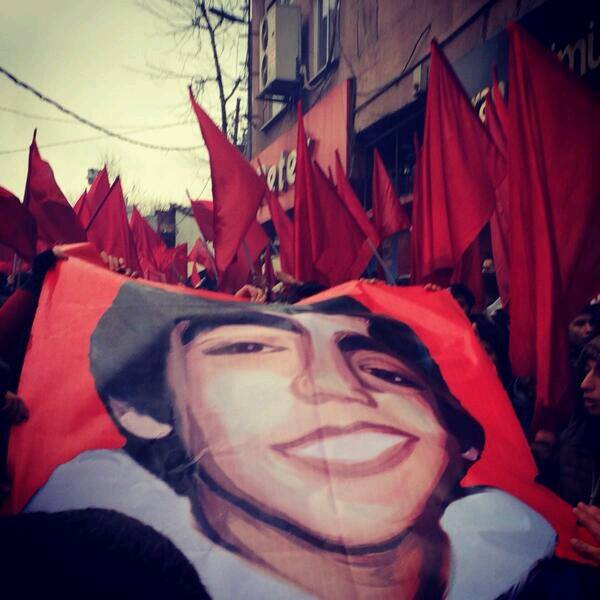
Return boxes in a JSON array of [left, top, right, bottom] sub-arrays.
[[0, 508, 209, 600]]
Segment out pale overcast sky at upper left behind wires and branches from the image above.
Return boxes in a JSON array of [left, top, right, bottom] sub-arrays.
[[0, 0, 243, 206]]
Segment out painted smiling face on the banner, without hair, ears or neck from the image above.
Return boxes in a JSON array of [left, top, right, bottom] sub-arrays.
[[169, 313, 458, 546]]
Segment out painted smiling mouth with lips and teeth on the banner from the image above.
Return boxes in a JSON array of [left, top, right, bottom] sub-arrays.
[[271, 422, 419, 477]]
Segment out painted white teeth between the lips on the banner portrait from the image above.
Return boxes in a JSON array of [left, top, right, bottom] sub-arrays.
[[288, 431, 408, 463]]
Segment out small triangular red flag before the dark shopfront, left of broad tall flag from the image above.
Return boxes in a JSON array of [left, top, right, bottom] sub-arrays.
[[372, 148, 410, 239]]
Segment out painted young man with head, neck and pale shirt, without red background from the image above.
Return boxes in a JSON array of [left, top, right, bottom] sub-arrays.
[[28, 283, 555, 598]]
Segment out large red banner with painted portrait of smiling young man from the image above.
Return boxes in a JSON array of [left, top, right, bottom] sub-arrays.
[[1, 248, 592, 600]]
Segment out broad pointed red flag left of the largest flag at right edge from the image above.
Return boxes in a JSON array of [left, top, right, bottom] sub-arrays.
[[413, 41, 505, 280]]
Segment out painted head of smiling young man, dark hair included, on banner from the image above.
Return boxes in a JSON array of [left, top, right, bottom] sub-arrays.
[[90, 284, 484, 597]]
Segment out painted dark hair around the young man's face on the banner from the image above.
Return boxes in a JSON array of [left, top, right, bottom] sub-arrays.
[[90, 282, 484, 493]]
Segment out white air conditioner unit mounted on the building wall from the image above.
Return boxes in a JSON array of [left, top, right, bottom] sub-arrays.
[[258, 3, 300, 97]]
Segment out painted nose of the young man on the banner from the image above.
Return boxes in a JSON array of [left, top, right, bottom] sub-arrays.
[[292, 347, 377, 407]]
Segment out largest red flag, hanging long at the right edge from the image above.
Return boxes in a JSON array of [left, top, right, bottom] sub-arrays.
[[507, 24, 600, 429]]
